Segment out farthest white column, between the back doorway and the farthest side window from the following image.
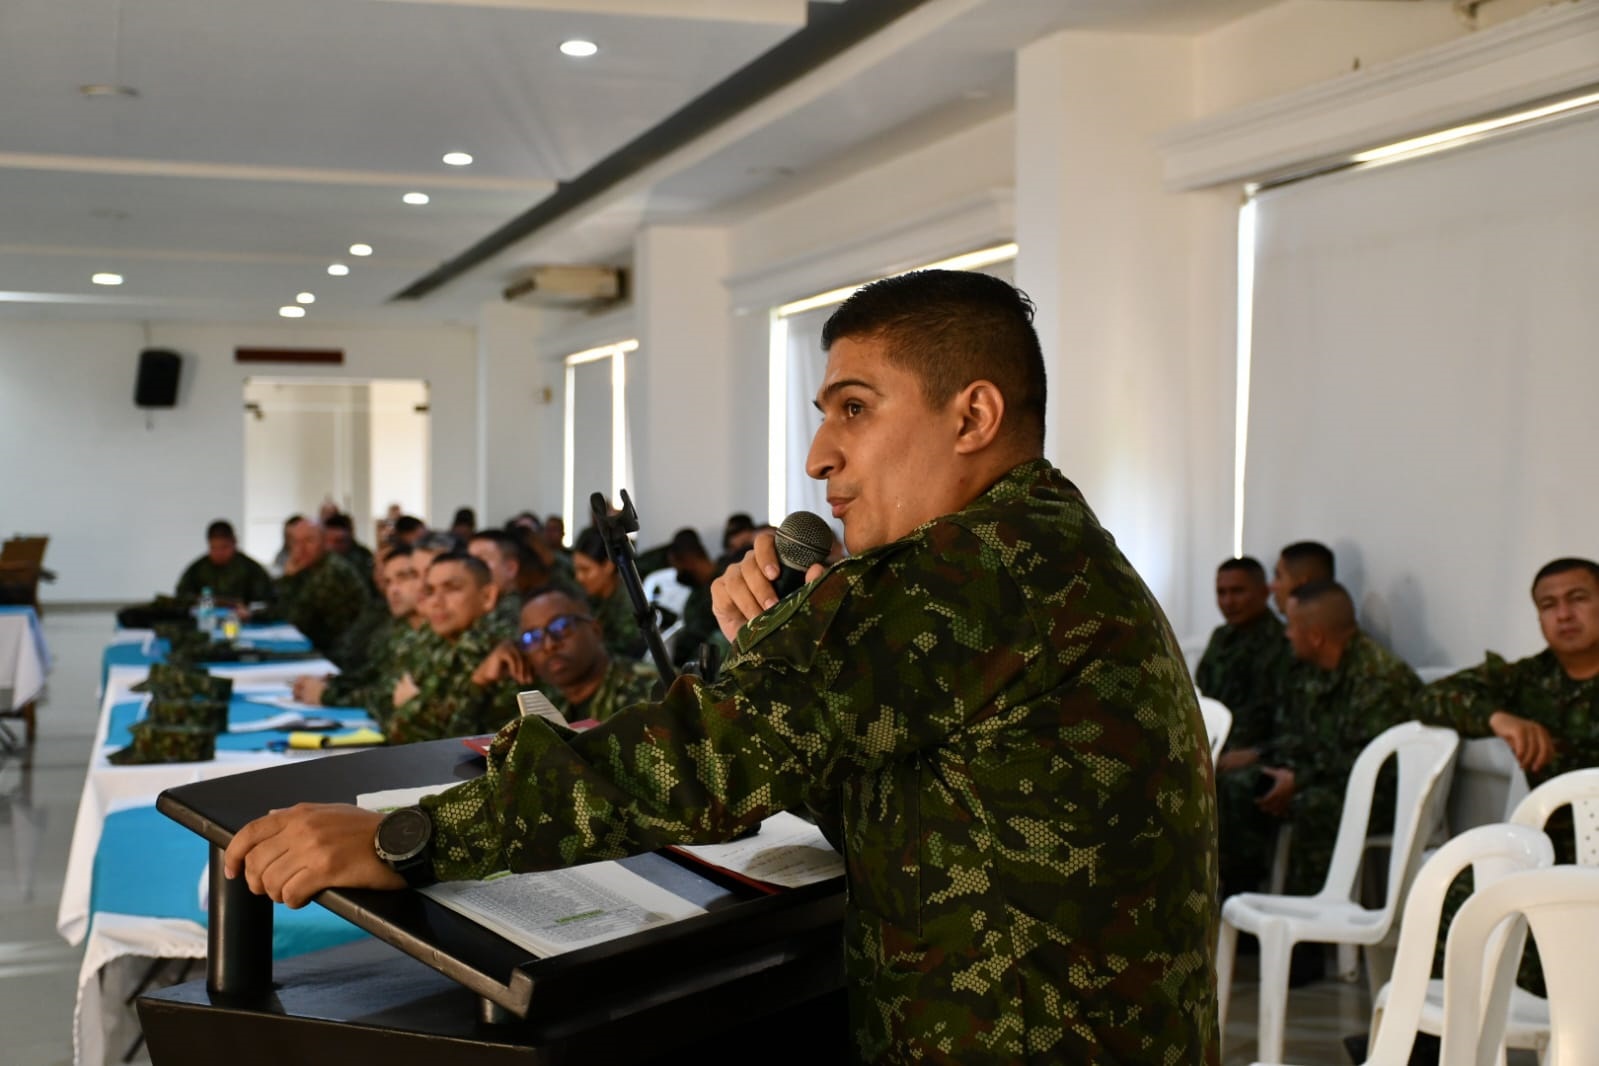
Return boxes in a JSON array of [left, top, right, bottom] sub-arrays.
[[470, 302, 563, 526]]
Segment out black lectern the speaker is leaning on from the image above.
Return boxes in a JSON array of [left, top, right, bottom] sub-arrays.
[[139, 740, 849, 1066]]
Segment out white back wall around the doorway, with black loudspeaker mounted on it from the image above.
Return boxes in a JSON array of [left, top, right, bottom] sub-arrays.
[[0, 320, 477, 603]]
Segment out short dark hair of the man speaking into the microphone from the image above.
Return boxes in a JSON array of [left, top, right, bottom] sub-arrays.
[[822, 270, 1049, 449]]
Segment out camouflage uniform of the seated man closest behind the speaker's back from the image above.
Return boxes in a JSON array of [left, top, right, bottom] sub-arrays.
[[1194, 611, 1294, 897]]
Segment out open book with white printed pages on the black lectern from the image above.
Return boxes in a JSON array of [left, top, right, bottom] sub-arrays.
[[357, 782, 844, 959]]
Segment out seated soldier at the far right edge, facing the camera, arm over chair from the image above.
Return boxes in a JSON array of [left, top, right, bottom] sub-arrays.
[[1426, 558, 1599, 996]]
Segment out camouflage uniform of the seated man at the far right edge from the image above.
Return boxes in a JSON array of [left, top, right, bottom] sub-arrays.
[[1426, 649, 1599, 996]]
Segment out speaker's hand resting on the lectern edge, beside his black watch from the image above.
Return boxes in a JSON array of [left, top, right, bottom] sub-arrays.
[[222, 804, 405, 908]]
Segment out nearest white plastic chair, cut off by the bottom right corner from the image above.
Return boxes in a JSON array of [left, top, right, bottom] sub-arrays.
[[1439, 866, 1599, 1066]]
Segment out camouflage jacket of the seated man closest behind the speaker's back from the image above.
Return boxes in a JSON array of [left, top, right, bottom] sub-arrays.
[[1194, 611, 1294, 751]]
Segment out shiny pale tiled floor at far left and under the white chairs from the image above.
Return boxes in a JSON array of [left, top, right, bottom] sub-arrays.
[[0, 611, 1419, 1066]]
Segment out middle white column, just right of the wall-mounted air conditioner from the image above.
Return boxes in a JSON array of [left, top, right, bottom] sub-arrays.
[[627, 225, 741, 543]]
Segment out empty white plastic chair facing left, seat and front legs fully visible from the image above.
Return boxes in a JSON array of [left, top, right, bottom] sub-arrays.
[[1217, 722, 1460, 1063]]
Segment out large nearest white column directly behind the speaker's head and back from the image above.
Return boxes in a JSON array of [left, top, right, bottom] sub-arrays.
[[1015, 32, 1236, 634]]
